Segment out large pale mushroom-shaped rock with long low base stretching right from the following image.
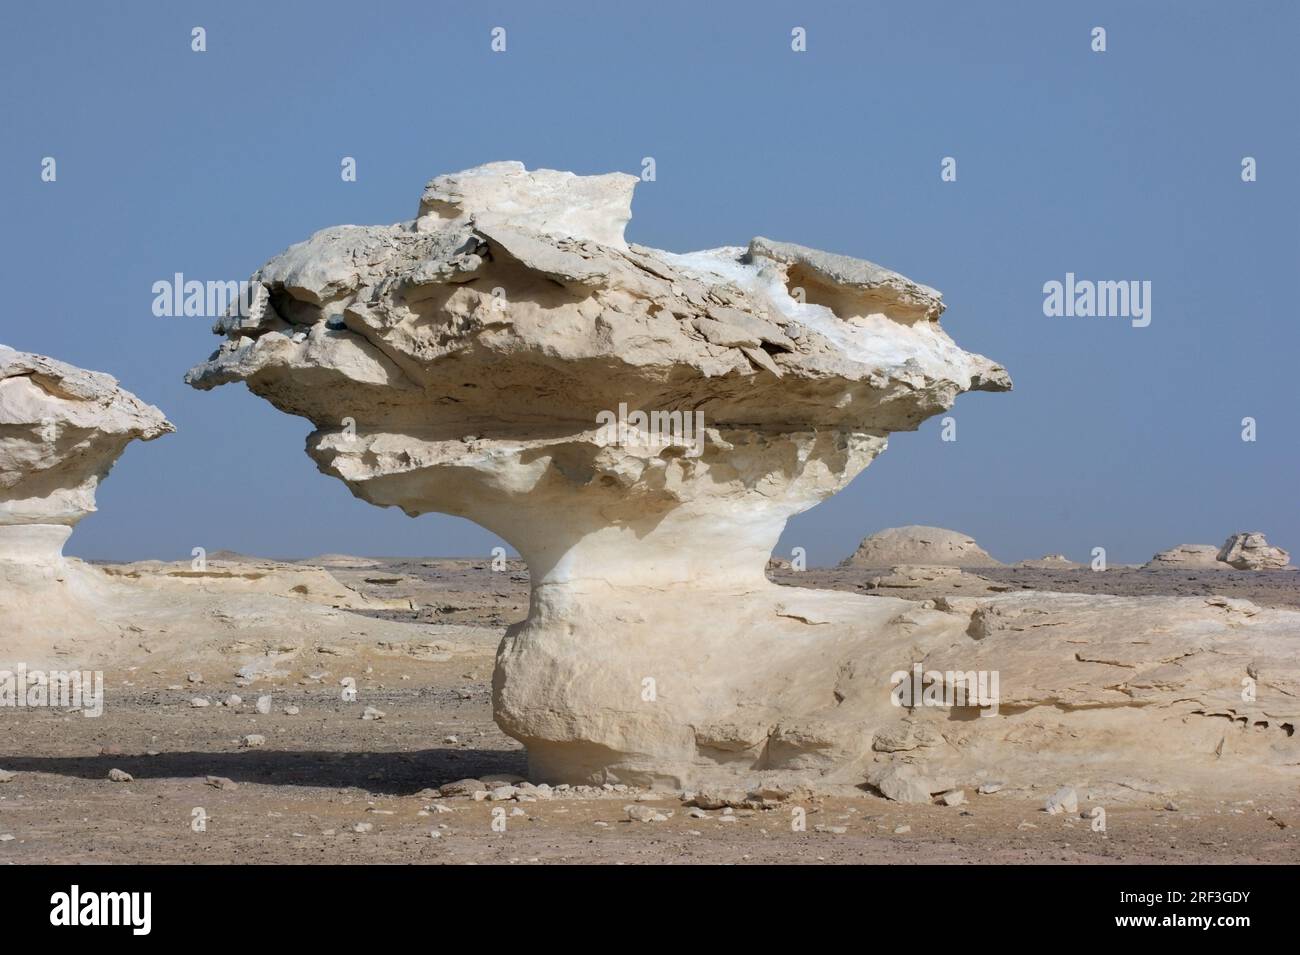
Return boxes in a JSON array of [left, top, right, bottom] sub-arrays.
[[187, 162, 1300, 789]]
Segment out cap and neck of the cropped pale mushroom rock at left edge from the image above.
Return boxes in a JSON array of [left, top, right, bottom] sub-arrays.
[[0, 346, 176, 574]]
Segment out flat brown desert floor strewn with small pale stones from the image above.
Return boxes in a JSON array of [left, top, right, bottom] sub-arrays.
[[0, 560, 1300, 864]]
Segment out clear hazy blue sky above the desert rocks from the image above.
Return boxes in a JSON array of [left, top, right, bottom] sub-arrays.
[[0, 0, 1300, 564]]
